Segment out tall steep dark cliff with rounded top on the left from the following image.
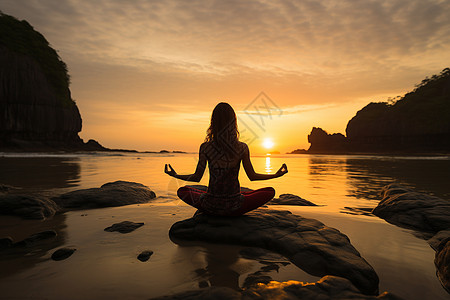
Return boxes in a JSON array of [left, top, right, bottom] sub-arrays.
[[0, 12, 83, 149]]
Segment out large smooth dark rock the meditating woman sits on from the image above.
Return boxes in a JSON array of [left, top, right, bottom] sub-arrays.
[[170, 209, 378, 294]]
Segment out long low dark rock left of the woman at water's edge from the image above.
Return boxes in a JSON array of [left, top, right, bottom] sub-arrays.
[[53, 181, 156, 208]]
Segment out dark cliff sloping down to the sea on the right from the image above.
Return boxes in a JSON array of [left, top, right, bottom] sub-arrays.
[[307, 68, 450, 153]]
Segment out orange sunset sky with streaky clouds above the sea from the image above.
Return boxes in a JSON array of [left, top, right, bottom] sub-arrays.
[[0, 0, 450, 153]]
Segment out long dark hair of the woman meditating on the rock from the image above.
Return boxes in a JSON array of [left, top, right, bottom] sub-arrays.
[[205, 102, 239, 153]]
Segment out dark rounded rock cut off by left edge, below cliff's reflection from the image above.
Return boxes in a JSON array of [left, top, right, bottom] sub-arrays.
[[0, 194, 58, 220]]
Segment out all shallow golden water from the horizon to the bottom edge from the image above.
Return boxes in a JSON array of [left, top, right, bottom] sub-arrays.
[[0, 153, 450, 299]]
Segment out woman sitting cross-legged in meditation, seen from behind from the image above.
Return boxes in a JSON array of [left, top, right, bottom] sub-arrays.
[[164, 102, 288, 216]]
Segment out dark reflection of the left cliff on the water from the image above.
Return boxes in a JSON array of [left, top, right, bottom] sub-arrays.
[[0, 157, 80, 190]]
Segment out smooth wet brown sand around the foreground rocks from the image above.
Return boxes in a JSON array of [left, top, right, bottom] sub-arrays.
[[0, 198, 448, 299]]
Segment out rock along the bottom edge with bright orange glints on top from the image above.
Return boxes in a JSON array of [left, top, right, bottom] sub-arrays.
[[154, 276, 401, 300]]
